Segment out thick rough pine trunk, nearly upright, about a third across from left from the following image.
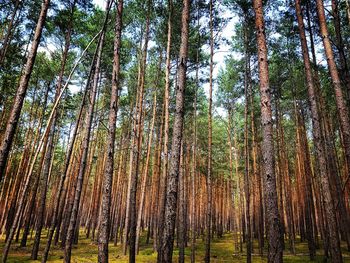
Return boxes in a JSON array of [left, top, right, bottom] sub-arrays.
[[98, 0, 123, 262]]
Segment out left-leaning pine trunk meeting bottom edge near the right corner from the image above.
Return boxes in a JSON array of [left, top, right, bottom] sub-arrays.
[[295, 0, 342, 262]]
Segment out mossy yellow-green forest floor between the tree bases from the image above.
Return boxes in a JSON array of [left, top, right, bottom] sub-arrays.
[[0, 233, 350, 263]]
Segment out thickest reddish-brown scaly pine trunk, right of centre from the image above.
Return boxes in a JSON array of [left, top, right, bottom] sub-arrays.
[[254, 0, 283, 262]]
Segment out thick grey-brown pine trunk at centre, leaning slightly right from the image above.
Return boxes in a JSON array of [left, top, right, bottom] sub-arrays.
[[160, 0, 190, 263]]
